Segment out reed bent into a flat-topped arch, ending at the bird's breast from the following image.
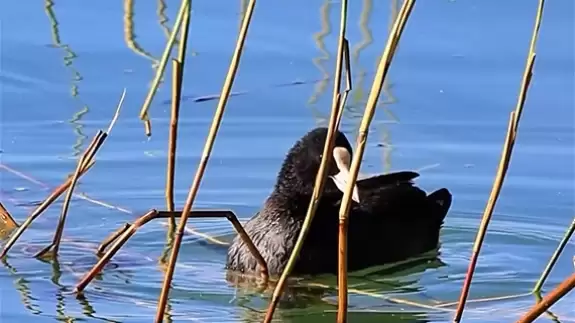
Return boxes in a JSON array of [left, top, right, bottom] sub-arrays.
[[75, 210, 267, 293]]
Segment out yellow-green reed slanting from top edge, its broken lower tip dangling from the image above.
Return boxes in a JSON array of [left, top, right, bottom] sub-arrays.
[[140, 0, 190, 136]]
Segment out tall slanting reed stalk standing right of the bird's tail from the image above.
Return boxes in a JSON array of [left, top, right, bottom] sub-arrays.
[[453, 0, 545, 323]]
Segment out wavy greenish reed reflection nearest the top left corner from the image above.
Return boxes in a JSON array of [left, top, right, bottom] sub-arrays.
[[44, 0, 90, 157]]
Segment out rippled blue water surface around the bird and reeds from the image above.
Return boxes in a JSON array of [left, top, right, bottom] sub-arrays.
[[0, 0, 575, 322]]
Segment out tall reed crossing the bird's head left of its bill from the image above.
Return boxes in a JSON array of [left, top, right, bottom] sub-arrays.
[[264, 0, 352, 323]]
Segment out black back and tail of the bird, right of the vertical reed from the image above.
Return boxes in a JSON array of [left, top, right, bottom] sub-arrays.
[[348, 172, 451, 270]]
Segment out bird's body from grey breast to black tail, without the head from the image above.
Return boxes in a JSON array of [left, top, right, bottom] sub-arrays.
[[227, 172, 451, 276]]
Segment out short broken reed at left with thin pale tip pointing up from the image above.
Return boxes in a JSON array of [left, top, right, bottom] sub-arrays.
[[36, 89, 126, 257]]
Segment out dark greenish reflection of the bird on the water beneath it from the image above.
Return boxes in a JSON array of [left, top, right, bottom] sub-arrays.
[[226, 250, 445, 322]]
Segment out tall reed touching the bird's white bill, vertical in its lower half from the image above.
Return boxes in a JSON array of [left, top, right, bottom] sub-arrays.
[[338, 0, 415, 323]]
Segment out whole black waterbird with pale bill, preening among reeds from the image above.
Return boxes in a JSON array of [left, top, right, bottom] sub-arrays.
[[226, 128, 451, 276]]
